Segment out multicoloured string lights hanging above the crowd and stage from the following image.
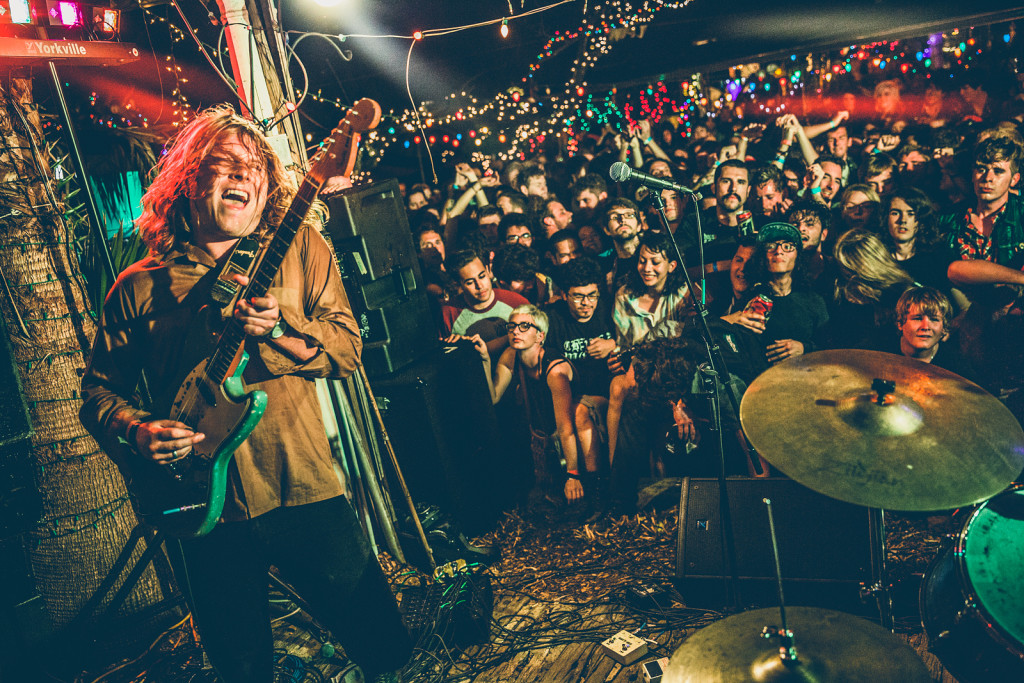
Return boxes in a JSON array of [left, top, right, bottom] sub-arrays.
[[117, 0, 999, 168]]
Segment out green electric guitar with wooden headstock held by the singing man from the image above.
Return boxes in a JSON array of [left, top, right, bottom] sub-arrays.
[[141, 99, 381, 538]]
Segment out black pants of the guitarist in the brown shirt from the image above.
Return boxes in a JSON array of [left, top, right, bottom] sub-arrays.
[[181, 497, 412, 683]]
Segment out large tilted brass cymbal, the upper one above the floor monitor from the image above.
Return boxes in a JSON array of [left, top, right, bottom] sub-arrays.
[[739, 349, 1024, 511]]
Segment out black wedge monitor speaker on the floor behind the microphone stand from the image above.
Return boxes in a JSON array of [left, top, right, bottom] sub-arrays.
[[676, 477, 877, 613]]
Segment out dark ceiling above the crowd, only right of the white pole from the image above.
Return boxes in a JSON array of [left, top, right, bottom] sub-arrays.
[[283, 0, 1024, 108]]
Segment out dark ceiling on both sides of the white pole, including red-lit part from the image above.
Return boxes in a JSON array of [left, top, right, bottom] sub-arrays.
[[37, 0, 1024, 144]]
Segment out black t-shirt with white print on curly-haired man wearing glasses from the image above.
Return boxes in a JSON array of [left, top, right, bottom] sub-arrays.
[[544, 296, 615, 396]]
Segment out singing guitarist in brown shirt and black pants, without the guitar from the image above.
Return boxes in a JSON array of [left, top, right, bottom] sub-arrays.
[[81, 105, 411, 683]]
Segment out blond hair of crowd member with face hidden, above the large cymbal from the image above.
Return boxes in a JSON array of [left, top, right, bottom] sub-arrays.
[[835, 229, 913, 304]]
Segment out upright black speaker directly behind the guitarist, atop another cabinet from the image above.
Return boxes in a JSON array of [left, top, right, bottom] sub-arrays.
[[326, 179, 438, 377]]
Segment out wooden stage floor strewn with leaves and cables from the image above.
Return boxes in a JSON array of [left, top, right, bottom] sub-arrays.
[[68, 480, 955, 683]]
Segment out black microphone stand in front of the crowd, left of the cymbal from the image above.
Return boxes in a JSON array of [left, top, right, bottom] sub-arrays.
[[650, 191, 740, 610]]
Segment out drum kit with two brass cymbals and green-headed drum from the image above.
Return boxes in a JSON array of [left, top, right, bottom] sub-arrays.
[[663, 350, 1024, 683]]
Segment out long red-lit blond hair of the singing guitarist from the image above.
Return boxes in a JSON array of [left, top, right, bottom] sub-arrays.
[[135, 104, 298, 254]]
